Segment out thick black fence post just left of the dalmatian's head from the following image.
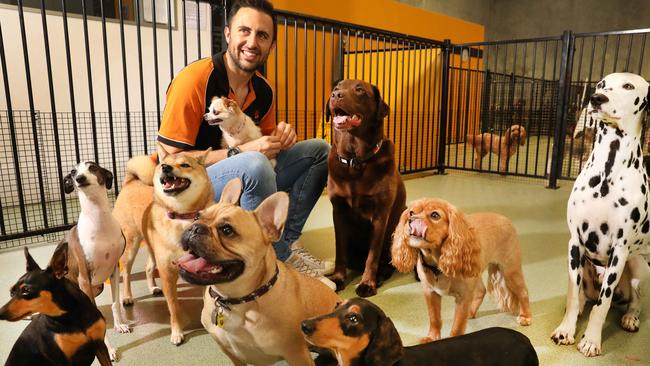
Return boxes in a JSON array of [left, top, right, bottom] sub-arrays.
[[548, 31, 575, 189]]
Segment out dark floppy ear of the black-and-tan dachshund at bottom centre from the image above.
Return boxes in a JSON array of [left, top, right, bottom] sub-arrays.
[[363, 314, 403, 365]]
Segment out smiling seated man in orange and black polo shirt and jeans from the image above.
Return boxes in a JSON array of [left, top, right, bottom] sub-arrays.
[[158, 0, 336, 288]]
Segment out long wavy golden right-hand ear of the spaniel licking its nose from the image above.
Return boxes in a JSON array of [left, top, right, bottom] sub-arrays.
[[438, 203, 481, 278]]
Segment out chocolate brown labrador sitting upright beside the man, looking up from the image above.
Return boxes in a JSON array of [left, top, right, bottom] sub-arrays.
[[327, 80, 406, 297]]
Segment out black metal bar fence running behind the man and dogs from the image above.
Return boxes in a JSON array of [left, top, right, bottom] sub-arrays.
[[0, 0, 650, 249]]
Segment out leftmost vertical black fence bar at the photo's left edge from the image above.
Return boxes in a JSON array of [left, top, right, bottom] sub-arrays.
[[0, 22, 27, 235]]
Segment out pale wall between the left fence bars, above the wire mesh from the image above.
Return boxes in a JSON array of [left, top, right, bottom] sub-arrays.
[[0, 2, 211, 112]]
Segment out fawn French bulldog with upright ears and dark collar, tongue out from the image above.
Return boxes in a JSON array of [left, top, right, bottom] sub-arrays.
[[178, 179, 340, 366]]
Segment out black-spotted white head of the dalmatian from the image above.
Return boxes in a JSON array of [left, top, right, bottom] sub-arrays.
[[588, 73, 650, 133]]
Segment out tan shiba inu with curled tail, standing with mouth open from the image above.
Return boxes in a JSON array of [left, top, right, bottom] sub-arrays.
[[113, 145, 214, 345]]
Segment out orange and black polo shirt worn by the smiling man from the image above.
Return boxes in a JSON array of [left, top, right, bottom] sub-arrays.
[[158, 51, 275, 150]]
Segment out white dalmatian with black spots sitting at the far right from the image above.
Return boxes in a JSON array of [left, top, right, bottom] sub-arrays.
[[551, 73, 650, 356]]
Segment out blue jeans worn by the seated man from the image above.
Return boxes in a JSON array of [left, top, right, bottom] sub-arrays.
[[208, 139, 330, 261]]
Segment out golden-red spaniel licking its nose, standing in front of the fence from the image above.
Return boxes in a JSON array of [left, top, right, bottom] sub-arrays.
[[391, 198, 531, 343]]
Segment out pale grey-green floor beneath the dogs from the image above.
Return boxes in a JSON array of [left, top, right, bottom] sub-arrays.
[[0, 172, 650, 366]]
